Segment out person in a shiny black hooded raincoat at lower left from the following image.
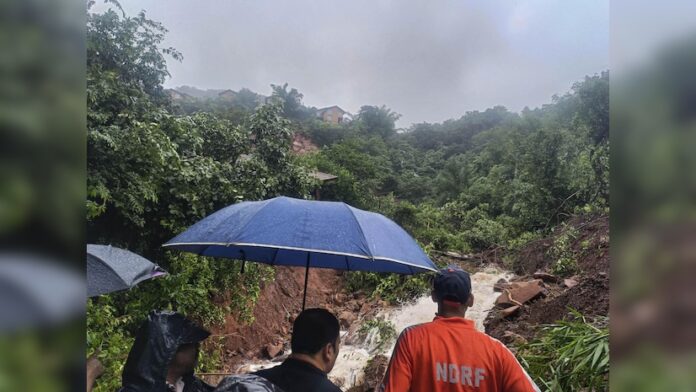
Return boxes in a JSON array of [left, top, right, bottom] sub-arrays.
[[120, 311, 214, 392]]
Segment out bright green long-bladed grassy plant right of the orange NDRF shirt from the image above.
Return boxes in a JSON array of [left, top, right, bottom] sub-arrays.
[[518, 310, 609, 392]]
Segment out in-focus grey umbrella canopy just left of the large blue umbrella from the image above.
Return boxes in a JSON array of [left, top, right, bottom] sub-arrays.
[[87, 244, 166, 297]]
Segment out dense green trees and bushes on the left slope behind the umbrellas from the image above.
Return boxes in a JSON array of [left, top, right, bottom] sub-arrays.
[[87, 5, 312, 391]]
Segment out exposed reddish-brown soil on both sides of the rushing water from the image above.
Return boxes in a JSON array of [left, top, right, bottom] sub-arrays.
[[201, 216, 610, 392]]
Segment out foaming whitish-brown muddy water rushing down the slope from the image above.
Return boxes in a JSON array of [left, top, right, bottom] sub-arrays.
[[245, 267, 512, 390]]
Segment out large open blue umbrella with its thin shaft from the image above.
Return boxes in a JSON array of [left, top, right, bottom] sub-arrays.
[[164, 197, 436, 309]]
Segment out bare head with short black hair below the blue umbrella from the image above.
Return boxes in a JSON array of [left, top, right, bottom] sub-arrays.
[[290, 309, 340, 373]]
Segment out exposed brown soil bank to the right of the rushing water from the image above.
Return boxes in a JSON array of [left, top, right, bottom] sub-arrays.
[[485, 216, 610, 343]]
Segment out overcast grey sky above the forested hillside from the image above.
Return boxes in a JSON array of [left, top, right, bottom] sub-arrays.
[[104, 0, 609, 127]]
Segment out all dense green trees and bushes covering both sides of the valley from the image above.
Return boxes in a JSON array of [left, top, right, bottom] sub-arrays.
[[86, 4, 609, 391]]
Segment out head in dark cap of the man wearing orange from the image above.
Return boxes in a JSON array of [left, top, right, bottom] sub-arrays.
[[432, 265, 474, 317]]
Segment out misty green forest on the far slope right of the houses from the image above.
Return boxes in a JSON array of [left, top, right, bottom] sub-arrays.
[[296, 72, 609, 302]]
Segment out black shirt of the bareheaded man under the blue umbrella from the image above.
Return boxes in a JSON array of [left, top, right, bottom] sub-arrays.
[[254, 358, 341, 392]]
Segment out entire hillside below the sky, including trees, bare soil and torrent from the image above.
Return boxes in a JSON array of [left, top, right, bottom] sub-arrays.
[[86, 6, 609, 391]]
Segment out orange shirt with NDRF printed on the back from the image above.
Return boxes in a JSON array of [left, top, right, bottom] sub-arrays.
[[380, 316, 539, 392]]
